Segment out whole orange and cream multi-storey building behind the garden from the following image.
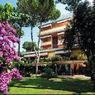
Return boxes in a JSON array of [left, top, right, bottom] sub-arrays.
[[24, 18, 86, 74]]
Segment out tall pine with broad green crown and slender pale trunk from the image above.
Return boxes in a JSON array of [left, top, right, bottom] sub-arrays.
[[17, 0, 60, 73]]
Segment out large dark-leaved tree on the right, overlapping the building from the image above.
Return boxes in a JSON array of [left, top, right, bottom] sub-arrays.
[[64, 1, 95, 80]]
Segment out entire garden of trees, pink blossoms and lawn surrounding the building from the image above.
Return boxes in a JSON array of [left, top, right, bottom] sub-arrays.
[[0, 0, 95, 95]]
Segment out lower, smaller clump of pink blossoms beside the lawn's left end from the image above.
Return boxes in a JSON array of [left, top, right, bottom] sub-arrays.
[[0, 68, 22, 95]]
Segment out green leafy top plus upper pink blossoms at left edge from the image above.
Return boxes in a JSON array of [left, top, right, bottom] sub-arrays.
[[0, 3, 19, 65]]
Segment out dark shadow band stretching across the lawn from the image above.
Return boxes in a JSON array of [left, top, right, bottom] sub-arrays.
[[10, 77, 94, 94]]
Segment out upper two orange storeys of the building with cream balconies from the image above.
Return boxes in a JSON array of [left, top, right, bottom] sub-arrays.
[[40, 20, 70, 50]]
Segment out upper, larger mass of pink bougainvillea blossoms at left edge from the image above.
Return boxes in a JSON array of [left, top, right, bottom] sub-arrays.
[[0, 21, 19, 65]]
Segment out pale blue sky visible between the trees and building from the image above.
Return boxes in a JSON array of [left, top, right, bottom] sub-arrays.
[[0, 0, 93, 51]]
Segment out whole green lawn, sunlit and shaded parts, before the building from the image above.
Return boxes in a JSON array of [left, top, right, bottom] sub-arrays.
[[9, 77, 95, 94]]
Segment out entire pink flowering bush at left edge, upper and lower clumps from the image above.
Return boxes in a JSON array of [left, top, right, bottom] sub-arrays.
[[0, 21, 22, 94]]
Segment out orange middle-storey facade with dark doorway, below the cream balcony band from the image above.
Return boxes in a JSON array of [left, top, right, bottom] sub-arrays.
[[41, 34, 64, 49]]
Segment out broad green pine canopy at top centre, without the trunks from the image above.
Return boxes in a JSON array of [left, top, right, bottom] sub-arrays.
[[17, 0, 60, 22]]
